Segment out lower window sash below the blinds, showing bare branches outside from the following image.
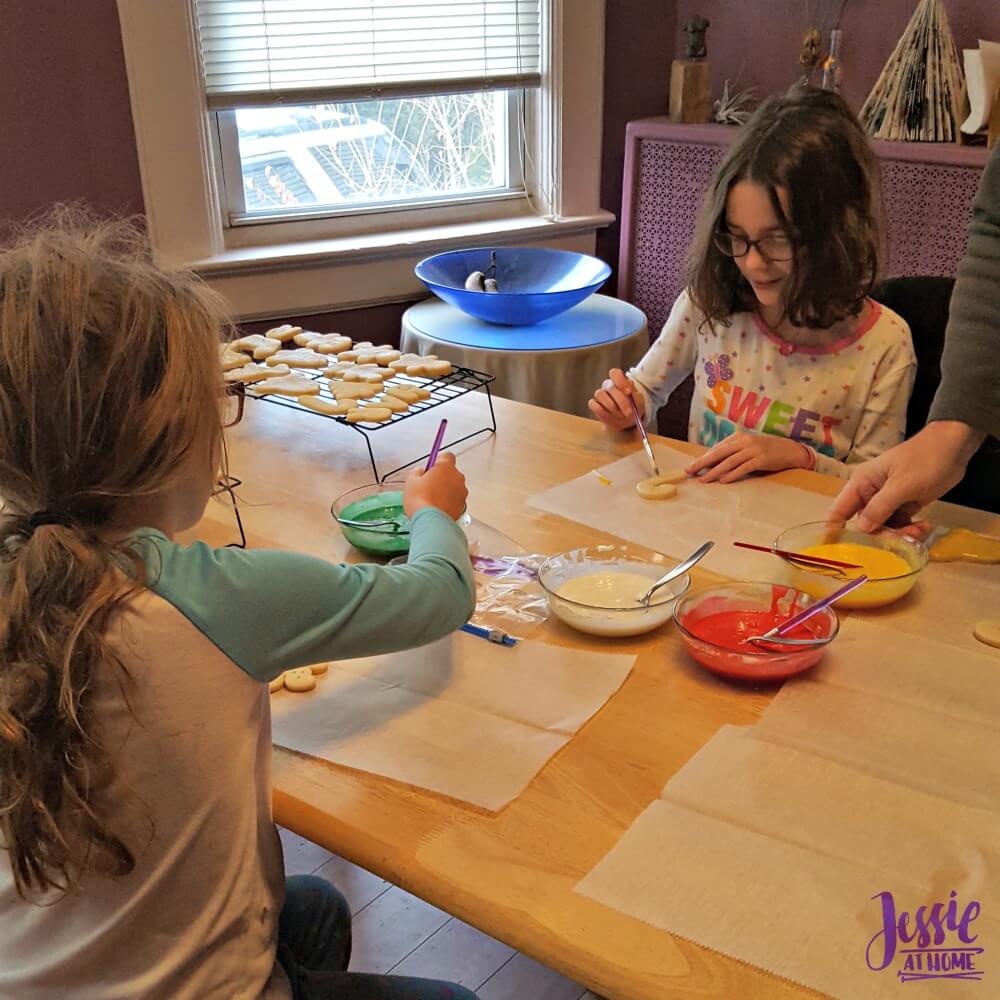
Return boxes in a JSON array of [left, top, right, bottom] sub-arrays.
[[217, 92, 524, 226]]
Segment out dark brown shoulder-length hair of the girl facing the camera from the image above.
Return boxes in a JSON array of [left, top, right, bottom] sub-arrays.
[[688, 86, 880, 329]]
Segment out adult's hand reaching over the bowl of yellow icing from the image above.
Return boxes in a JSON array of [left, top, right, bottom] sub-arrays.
[[829, 420, 985, 537]]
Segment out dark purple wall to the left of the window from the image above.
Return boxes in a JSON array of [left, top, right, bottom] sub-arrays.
[[0, 0, 143, 225]]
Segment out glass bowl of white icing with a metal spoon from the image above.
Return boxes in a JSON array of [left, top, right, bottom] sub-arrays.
[[538, 544, 691, 638]]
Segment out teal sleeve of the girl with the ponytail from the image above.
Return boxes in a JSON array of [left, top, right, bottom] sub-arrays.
[[141, 507, 475, 681]]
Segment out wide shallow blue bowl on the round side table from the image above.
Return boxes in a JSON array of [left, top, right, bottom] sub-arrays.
[[416, 247, 611, 326]]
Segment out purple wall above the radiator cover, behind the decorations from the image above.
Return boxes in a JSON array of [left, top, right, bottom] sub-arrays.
[[671, 0, 1000, 111]]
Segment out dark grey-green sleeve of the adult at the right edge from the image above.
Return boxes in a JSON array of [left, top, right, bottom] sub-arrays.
[[929, 143, 1000, 437]]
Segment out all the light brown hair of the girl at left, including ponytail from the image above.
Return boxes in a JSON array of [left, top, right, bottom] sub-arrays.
[[0, 209, 226, 898]]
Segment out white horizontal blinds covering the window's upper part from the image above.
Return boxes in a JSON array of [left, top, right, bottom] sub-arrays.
[[195, 0, 540, 109]]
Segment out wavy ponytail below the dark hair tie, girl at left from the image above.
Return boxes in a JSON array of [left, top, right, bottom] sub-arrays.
[[0, 513, 141, 897]]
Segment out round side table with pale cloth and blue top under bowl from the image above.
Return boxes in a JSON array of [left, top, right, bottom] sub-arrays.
[[401, 295, 649, 417]]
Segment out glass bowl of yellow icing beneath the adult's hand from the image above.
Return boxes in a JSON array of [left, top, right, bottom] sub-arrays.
[[774, 521, 930, 610]]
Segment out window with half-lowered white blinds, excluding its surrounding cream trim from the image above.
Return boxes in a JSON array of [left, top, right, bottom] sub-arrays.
[[196, 0, 541, 225]]
